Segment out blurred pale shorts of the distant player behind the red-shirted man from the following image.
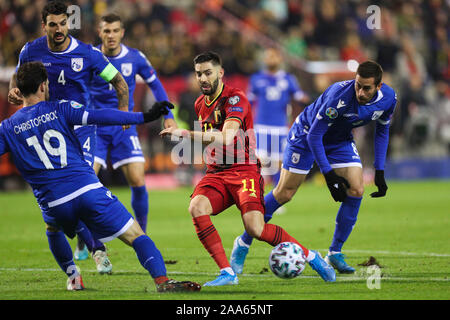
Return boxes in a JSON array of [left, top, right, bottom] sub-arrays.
[[255, 125, 288, 161]]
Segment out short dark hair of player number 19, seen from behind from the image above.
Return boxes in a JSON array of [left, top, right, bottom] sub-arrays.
[[16, 61, 48, 97]]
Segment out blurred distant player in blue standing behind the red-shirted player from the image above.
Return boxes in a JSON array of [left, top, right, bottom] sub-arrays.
[[247, 47, 308, 186]]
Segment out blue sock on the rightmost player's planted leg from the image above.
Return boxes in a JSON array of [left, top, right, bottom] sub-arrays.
[[329, 196, 362, 252]]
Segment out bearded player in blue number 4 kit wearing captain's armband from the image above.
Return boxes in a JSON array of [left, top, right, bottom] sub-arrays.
[[8, 1, 129, 273]]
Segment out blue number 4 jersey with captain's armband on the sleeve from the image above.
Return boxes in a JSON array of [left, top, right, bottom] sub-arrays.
[[16, 36, 117, 108]]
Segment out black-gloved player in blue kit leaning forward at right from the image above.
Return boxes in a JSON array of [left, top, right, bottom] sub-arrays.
[[230, 61, 397, 273]]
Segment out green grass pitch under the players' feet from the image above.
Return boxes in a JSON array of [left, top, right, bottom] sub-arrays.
[[0, 181, 450, 300]]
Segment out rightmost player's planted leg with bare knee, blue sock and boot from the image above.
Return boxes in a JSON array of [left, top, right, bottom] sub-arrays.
[[326, 166, 364, 273]]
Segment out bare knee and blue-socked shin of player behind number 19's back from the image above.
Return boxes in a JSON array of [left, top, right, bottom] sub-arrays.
[[121, 162, 148, 232]]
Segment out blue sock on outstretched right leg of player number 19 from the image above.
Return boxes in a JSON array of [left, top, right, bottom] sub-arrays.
[[133, 235, 167, 278]]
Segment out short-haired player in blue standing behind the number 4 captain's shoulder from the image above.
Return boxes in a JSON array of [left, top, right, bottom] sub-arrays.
[[91, 13, 177, 232]]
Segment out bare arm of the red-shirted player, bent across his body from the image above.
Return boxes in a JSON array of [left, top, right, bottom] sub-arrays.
[[159, 118, 241, 145]]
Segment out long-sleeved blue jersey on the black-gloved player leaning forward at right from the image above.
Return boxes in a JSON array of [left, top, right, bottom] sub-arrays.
[[288, 80, 397, 173]]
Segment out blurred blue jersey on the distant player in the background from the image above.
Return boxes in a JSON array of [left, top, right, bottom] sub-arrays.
[[247, 71, 304, 127]]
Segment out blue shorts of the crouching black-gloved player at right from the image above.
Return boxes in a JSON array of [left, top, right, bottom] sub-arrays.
[[283, 139, 362, 174]]
